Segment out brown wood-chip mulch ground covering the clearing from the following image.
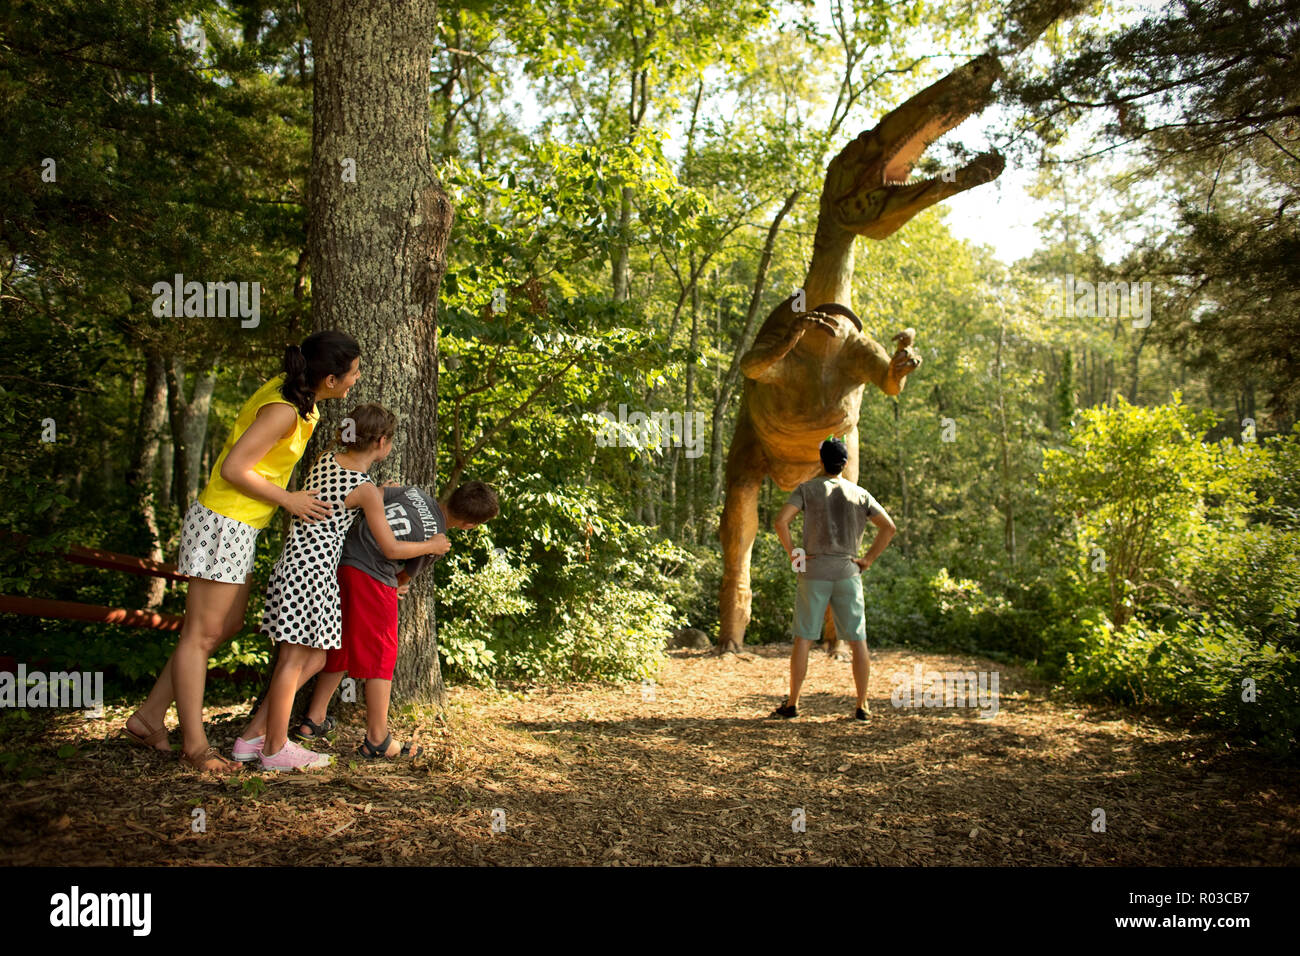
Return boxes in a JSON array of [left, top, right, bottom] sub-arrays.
[[0, 645, 1300, 866]]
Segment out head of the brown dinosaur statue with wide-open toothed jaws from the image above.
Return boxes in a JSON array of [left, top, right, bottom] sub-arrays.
[[822, 55, 1005, 239]]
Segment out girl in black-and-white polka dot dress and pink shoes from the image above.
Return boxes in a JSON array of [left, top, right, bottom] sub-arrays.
[[234, 405, 450, 770]]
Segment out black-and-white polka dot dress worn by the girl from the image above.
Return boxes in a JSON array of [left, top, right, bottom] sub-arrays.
[[261, 453, 371, 650]]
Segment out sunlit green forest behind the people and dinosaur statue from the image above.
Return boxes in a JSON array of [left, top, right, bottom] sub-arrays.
[[0, 0, 1300, 750]]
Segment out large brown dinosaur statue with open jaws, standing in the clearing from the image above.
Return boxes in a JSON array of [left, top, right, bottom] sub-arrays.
[[719, 55, 1004, 653]]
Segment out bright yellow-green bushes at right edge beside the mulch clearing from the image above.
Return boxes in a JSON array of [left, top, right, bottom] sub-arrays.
[[1044, 418, 1300, 750]]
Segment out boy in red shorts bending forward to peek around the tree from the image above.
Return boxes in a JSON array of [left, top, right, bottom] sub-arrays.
[[298, 481, 498, 758]]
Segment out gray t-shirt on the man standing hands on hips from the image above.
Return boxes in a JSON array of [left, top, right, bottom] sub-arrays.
[[787, 475, 881, 581]]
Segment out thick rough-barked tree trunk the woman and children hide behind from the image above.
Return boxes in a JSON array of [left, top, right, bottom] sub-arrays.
[[307, 0, 451, 706]]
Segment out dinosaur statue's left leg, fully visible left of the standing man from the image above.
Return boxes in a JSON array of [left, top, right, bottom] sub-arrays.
[[718, 406, 767, 653]]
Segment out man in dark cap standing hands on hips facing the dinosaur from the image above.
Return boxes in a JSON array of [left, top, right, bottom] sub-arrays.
[[772, 437, 897, 721]]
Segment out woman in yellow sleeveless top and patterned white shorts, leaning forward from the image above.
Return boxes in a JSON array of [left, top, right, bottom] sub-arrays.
[[126, 332, 361, 773]]
